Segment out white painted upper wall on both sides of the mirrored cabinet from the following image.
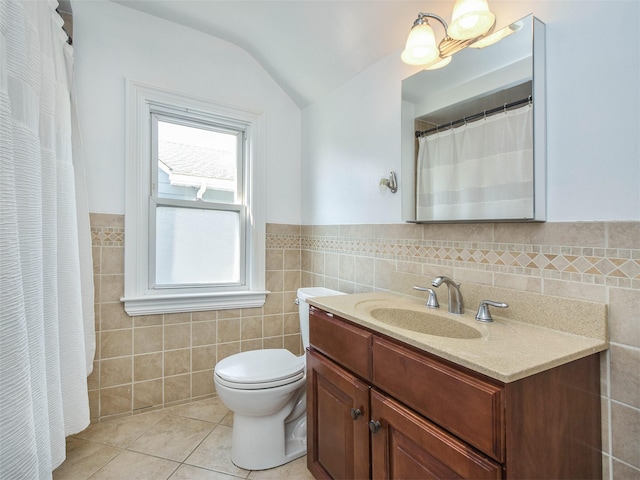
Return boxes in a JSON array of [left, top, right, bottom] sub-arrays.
[[302, 0, 640, 224]]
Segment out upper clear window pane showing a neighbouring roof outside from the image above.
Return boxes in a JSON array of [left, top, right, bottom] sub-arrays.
[[157, 120, 238, 203]]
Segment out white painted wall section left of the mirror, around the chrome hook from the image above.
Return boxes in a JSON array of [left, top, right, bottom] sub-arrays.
[[302, 57, 409, 224]]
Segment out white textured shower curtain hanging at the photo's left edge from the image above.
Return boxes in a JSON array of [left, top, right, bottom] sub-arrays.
[[0, 0, 94, 480]]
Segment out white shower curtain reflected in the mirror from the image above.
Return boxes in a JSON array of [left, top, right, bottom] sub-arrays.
[[416, 105, 533, 221]]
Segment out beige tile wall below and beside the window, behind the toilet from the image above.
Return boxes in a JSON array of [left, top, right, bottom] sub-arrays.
[[89, 214, 302, 421]]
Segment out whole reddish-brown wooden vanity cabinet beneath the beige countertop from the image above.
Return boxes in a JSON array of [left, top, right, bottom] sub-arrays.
[[307, 307, 601, 480]]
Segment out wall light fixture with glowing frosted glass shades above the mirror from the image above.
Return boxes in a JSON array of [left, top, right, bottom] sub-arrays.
[[401, 0, 495, 70]]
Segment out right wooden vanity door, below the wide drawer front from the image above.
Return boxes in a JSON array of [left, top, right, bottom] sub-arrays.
[[371, 390, 502, 479]]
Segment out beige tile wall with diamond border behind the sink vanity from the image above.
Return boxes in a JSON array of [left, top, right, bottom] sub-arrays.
[[301, 222, 640, 479]]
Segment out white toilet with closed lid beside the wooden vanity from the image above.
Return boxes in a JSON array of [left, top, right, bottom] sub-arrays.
[[213, 287, 343, 470]]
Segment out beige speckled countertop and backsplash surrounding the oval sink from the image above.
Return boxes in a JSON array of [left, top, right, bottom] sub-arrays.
[[307, 292, 609, 383]]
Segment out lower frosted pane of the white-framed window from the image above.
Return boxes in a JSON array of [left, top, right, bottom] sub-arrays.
[[156, 206, 240, 285]]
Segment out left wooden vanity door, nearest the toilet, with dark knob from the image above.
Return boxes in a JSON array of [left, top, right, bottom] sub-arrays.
[[307, 350, 370, 480]]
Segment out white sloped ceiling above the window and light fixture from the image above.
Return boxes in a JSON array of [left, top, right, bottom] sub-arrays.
[[100, 0, 453, 107]]
